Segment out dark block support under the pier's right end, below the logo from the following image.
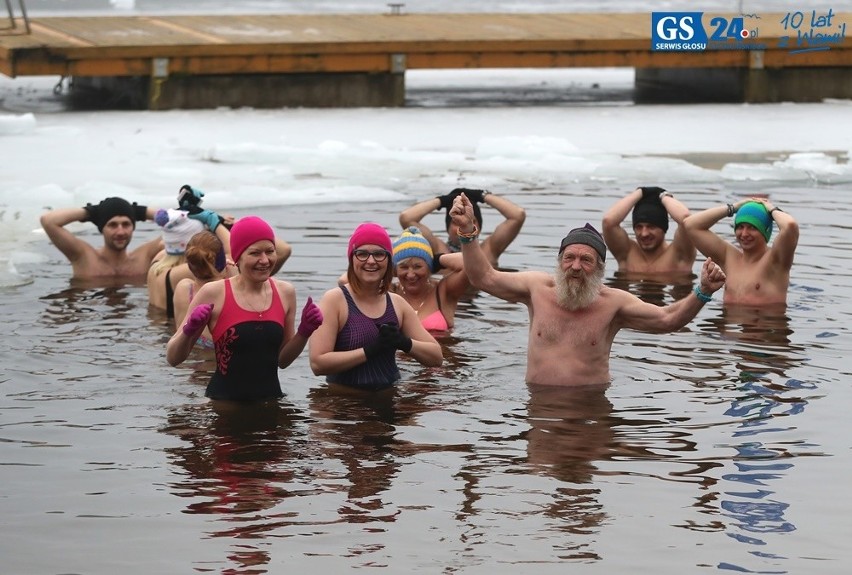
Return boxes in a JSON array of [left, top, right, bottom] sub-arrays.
[[633, 68, 852, 104]]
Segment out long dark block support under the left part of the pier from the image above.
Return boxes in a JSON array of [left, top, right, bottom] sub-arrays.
[[71, 73, 405, 110]]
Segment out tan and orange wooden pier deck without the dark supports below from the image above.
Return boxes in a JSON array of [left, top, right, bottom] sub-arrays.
[[0, 13, 852, 76]]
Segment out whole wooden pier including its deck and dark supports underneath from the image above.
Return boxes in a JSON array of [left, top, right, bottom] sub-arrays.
[[0, 13, 852, 109]]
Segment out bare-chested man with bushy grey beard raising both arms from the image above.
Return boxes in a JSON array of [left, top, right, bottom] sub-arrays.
[[450, 194, 725, 386]]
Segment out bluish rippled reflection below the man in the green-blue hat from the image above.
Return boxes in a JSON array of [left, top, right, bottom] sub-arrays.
[[705, 305, 823, 572]]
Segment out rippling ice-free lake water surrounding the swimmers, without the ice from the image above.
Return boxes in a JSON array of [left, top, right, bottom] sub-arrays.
[[0, 170, 852, 575]]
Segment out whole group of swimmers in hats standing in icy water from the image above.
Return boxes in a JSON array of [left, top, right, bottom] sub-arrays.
[[41, 186, 798, 401]]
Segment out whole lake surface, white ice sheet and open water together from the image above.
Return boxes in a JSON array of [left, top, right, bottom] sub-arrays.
[[0, 3, 852, 575]]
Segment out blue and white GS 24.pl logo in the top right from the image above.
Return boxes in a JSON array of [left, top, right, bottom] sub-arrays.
[[651, 12, 757, 52]]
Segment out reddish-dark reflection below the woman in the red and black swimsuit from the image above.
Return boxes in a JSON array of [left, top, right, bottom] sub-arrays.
[[161, 401, 310, 573]]
